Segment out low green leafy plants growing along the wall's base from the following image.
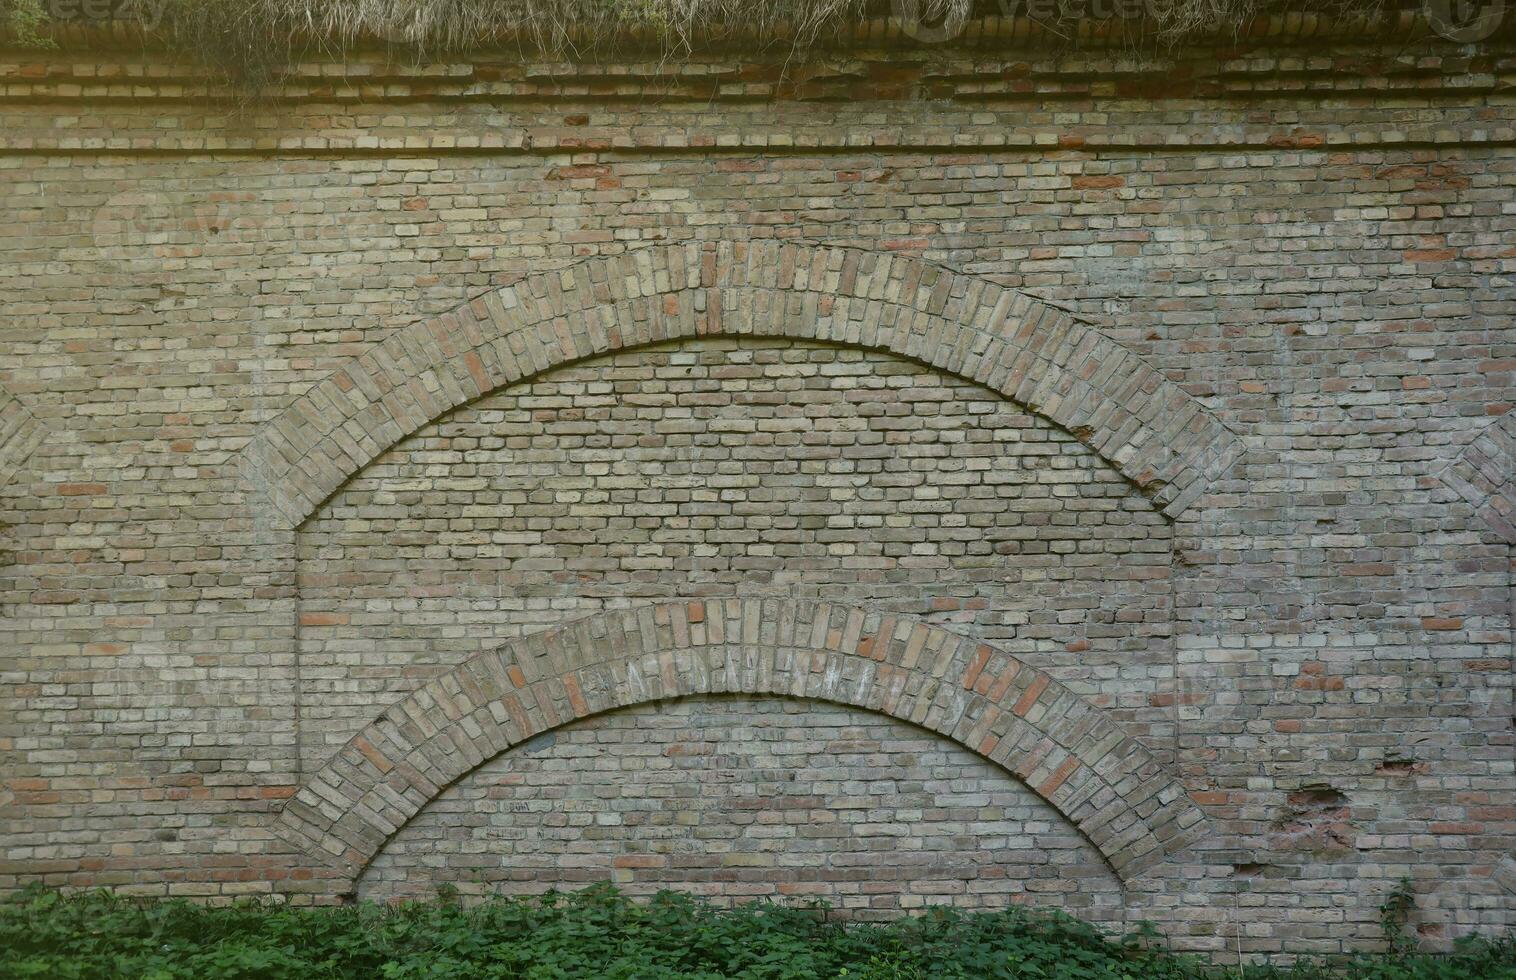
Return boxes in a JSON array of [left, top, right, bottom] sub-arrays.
[[0, 886, 1516, 980]]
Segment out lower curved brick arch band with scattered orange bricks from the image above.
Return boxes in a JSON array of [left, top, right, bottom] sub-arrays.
[[277, 599, 1205, 881]]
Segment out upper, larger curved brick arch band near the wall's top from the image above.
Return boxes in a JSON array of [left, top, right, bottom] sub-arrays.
[[241, 243, 1242, 526]]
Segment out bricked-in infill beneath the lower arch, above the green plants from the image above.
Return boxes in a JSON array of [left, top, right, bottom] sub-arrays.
[[355, 695, 1142, 927]]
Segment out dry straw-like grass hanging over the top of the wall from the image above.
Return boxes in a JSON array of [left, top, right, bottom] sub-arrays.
[[0, 0, 1386, 82]]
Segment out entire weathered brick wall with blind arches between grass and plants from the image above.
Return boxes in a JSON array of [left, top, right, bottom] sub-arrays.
[[0, 41, 1516, 957]]
